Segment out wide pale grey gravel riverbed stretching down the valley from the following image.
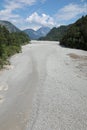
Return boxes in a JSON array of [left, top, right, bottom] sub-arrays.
[[0, 41, 87, 130]]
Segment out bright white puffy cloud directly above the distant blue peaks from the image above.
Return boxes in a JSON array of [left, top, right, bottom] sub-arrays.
[[26, 12, 55, 27]]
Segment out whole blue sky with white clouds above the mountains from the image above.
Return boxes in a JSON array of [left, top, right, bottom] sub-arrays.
[[0, 0, 87, 30]]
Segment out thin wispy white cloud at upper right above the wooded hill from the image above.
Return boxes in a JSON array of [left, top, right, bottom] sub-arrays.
[[56, 4, 87, 21]]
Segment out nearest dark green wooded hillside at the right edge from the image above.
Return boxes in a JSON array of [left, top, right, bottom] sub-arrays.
[[60, 15, 87, 50]]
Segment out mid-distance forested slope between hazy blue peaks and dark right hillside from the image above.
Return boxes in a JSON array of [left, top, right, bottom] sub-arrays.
[[40, 26, 69, 41]]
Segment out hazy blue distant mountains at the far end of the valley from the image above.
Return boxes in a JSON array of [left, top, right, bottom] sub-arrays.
[[24, 27, 50, 39]]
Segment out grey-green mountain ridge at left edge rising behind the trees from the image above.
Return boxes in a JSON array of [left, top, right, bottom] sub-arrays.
[[0, 20, 21, 33]]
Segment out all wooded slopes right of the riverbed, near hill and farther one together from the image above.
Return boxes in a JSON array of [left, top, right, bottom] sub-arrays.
[[39, 15, 87, 50]]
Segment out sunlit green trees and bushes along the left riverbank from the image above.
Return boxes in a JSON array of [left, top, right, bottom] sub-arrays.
[[0, 26, 29, 68]]
